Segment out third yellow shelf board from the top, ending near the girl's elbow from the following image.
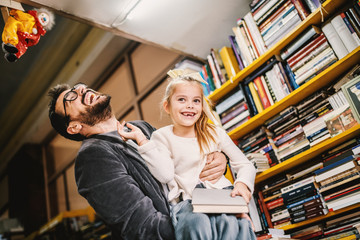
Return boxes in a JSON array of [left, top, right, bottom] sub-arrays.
[[255, 124, 360, 184]]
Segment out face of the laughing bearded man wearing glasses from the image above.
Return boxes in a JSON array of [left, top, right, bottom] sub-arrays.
[[56, 85, 112, 126]]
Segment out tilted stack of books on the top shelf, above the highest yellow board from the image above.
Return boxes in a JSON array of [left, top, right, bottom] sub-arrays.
[[250, 0, 302, 48]]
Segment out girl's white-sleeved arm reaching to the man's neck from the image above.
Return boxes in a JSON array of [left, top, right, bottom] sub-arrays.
[[118, 122, 175, 184]]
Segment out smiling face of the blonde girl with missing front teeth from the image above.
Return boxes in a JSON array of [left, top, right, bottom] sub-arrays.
[[164, 82, 203, 130]]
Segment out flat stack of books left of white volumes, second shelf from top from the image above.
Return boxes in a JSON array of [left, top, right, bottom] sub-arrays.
[[281, 26, 337, 87]]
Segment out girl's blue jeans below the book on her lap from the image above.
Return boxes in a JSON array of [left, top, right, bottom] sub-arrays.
[[171, 200, 256, 240]]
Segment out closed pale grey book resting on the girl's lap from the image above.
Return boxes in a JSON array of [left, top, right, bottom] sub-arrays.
[[192, 188, 249, 213]]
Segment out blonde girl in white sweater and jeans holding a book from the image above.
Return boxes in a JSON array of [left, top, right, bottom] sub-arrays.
[[118, 70, 256, 239]]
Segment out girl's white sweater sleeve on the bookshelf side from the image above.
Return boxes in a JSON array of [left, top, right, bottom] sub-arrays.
[[217, 129, 256, 192]]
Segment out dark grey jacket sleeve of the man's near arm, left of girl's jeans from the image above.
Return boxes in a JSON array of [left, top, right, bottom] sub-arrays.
[[75, 139, 174, 239]]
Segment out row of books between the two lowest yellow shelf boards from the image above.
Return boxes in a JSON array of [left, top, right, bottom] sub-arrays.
[[250, 138, 360, 239]]
